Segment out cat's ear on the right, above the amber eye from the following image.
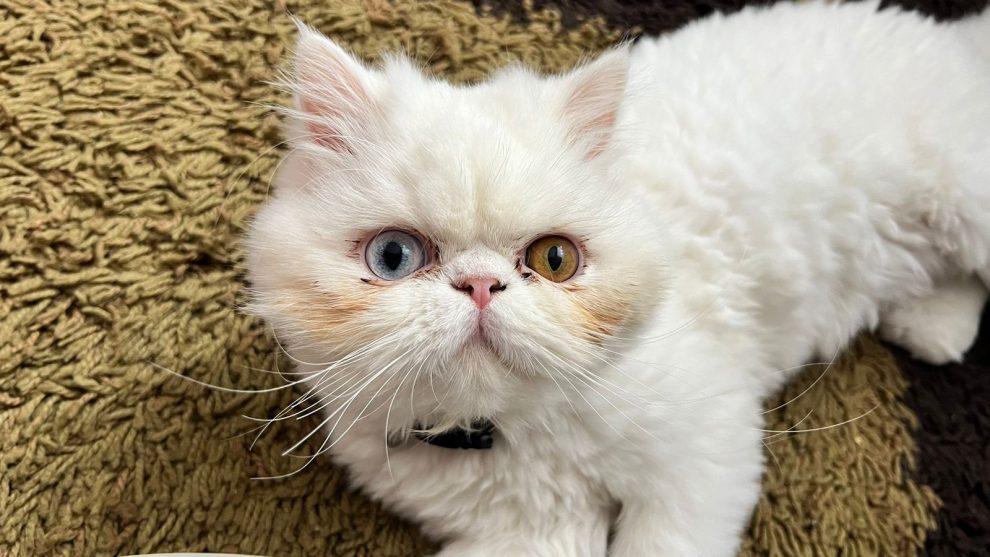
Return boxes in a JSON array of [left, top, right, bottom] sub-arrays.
[[562, 46, 629, 159]]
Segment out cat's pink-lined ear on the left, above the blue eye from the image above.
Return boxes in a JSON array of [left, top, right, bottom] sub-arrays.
[[291, 20, 378, 155]]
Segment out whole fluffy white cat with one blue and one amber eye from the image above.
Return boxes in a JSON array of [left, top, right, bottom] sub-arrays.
[[249, 2, 990, 557]]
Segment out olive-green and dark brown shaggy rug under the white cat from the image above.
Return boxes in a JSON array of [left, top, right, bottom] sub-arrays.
[[0, 0, 990, 557]]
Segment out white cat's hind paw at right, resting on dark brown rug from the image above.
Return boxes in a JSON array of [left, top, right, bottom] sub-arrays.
[[879, 277, 987, 365]]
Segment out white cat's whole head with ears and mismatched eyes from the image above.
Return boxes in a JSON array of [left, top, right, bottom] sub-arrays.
[[249, 30, 663, 419]]
